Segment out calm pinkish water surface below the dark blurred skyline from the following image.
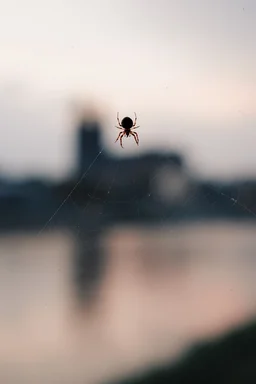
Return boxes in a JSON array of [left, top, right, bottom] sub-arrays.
[[0, 223, 256, 384]]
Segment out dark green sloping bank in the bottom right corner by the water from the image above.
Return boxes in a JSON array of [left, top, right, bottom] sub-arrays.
[[112, 323, 256, 384]]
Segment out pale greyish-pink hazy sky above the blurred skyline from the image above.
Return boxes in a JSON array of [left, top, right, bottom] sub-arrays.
[[0, 0, 256, 177]]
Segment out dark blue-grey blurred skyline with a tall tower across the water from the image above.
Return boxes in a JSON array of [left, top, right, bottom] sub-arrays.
[[0, 109, 256, 231]]
